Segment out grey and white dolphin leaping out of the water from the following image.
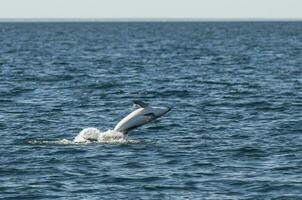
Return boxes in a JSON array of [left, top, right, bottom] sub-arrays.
[[114, 100, 171, 134]]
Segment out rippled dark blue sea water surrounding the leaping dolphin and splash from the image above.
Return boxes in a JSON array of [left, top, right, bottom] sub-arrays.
[[0, 22, 302, 199]]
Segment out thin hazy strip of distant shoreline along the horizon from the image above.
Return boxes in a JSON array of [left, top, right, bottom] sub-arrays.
[[0, 18, 302, 22]]
